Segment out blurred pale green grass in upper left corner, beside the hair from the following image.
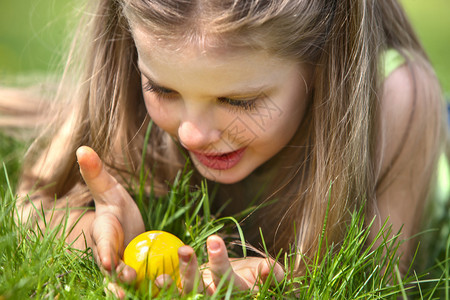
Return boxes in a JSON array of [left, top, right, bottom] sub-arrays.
[[0, 0, 77, 76]]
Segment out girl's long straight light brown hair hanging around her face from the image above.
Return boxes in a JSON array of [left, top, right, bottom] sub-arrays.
[[16, 0, 442, 272]]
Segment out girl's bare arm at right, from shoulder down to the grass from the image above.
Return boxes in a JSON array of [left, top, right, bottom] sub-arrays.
[[372, 61, 442, 270]]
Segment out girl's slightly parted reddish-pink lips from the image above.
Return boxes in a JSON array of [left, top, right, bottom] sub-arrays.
[[191, 148, 246, 170]]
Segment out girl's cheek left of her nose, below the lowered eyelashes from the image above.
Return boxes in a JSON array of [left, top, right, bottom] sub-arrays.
[[144, 93, 179, 135]]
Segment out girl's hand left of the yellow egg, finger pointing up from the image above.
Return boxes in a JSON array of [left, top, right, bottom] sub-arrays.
[[76, 146, 145, 297]]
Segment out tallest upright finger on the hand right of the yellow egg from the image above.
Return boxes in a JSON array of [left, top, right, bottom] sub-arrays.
[[206, 235, 247, 290]]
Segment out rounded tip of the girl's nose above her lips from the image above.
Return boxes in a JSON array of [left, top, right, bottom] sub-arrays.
[[178, 120, 220, 151]]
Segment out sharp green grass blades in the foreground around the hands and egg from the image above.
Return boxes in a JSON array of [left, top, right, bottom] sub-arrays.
[[0, 132, 450, 300]]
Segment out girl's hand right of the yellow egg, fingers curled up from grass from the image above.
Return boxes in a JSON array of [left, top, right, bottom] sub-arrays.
[[178, 235, 284, 295]]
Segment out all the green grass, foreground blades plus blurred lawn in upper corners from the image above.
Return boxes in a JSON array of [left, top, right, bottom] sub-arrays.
[[0, 0, 450, 300]]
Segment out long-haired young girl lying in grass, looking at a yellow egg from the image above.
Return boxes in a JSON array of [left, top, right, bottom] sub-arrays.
[[14, 0, 444, 293]]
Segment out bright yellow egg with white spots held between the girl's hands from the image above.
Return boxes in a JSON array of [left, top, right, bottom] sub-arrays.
[[123, 230, 184, 296]]
